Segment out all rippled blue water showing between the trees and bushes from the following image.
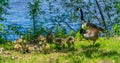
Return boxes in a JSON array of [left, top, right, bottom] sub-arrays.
[[3, 0, 79, 40]]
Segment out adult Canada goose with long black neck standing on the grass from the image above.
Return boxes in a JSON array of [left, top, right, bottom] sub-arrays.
[[79, 9, 104, 44]]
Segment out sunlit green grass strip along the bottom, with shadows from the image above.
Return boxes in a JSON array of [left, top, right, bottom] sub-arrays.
[[0, 38, 120, 63]]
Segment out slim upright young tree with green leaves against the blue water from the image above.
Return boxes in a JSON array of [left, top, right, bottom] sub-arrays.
[[28, 0, 40, 33]]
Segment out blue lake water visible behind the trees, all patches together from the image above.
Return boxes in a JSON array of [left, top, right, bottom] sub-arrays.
[[3, 0, 79, 40]]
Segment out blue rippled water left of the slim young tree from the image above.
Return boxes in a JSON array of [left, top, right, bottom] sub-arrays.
[[4, 0, 31, 40]]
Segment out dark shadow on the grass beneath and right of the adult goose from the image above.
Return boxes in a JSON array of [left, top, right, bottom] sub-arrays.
[[79, 43, 120, 58]]
